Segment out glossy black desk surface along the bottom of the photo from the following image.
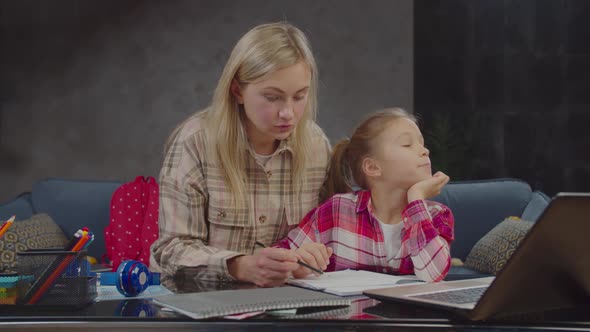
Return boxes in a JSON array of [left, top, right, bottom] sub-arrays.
[[0, 278, 590, 332]]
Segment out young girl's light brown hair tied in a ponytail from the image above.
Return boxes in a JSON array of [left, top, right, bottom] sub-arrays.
[[324, 108, 417, 198]]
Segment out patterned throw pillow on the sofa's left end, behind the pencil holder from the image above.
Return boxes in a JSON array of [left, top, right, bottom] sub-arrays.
[[0, 213, 68, 273]]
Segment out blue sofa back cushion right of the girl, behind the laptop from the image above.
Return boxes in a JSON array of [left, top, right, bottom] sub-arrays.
[[433, 179, 532, 260]]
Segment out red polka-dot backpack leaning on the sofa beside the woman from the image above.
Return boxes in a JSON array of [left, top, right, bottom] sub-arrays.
[[104, 176, 159, 271]]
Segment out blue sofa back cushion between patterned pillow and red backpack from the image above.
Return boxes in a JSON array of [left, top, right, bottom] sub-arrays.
[[32, 179, 122, 258]]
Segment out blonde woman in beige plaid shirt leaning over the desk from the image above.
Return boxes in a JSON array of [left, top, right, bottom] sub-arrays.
[[150, 23, 330, 286]]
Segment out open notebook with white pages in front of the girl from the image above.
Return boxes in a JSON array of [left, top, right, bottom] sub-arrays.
[[287, 270, 420, 296]]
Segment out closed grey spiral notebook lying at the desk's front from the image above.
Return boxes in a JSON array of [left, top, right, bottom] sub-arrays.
[[153, 286, 351, 319]]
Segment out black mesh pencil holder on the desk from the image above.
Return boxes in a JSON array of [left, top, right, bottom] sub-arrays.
[[16, 249, 96, 307]]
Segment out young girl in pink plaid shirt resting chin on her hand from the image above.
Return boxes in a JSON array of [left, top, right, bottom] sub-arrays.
[[275, 109, 454, 282]]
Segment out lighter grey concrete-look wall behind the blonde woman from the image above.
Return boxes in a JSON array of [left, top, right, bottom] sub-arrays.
[[0, 0, 413, 202]]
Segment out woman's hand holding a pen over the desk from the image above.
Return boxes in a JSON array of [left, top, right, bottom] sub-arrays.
[[227, 248, 299, 287]]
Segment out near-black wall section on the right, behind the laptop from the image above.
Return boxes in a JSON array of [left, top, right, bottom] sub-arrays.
[[414, 0, 590, 195]]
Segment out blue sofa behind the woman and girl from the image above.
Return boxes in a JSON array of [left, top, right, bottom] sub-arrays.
[[0, 178, 549, 278]]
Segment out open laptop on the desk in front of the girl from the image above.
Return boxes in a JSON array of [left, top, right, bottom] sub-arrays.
[[363, 193, 590, 320]]
